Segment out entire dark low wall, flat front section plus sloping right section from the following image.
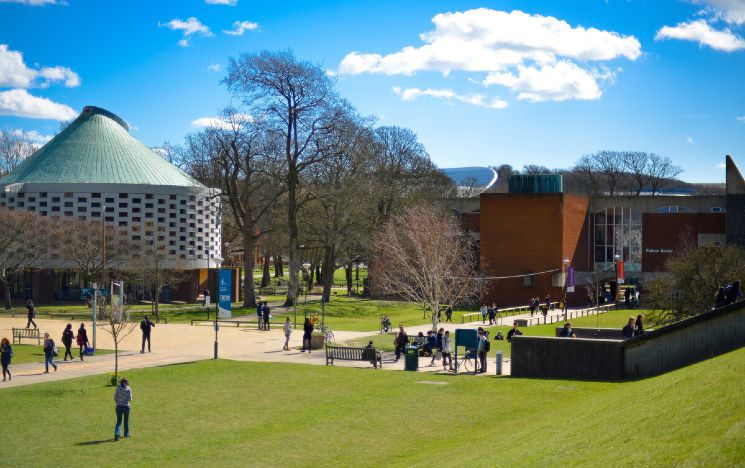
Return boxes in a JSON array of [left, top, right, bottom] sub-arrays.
[[511, 301, 745, 380]]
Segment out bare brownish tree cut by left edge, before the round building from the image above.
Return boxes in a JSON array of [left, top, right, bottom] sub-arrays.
[[0, 208, 58, 309]]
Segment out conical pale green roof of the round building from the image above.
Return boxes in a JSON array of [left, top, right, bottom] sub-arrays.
[[0, 106, 202, 187]]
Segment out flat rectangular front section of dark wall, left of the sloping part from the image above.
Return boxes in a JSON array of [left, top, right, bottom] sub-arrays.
[[510, 335, 623, 379]]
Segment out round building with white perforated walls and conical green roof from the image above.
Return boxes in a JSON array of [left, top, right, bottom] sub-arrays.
[[0, 106, 221, 302]]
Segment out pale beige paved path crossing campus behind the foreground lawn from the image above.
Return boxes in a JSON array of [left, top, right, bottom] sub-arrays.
[[0, 313, 612, 389]]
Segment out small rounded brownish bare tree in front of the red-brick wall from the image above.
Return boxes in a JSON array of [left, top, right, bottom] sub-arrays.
[[370, 205, 482, 330]]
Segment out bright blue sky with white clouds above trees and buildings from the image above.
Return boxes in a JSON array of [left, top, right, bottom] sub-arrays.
[[0, 0, 745, 182]]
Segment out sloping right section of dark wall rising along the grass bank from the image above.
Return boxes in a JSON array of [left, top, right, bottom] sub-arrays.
[[624, 301, 745, 378]]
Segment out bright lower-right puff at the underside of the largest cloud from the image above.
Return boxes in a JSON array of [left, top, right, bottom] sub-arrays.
[[484, 60, 602, 102]]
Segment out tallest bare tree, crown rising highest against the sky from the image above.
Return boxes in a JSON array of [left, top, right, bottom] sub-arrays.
[[223, 51, 345, 305]]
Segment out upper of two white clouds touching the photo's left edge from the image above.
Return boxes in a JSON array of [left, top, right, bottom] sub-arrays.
[[0, 44, 80, 88]]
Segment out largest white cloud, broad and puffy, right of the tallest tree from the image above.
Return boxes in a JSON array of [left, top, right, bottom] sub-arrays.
[[339, 8, 641, 101]]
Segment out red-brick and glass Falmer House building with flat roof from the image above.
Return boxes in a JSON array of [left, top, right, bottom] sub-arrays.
[[468, 156, 745, 307]]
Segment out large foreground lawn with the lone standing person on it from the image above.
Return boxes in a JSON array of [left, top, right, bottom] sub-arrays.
[[0, 349, 745, 466]]
